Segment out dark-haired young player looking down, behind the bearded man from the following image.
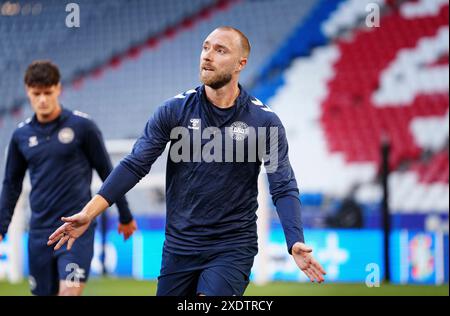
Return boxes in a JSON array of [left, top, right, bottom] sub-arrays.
[[0, 61, 137, 296]]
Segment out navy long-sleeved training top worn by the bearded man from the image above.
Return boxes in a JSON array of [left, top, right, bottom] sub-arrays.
[[99, 86, 304, 254]]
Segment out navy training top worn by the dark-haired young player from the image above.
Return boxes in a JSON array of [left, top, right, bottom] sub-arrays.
[[0, 109, 132, 235]]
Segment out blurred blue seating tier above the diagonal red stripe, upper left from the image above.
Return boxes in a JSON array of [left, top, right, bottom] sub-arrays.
[[0, 0, 215, 116]]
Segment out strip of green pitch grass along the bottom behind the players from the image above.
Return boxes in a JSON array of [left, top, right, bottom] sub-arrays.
[[0, 278, 449, 296]]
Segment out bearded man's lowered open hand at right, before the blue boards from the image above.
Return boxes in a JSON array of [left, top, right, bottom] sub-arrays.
[[292, 242, 327, 283]]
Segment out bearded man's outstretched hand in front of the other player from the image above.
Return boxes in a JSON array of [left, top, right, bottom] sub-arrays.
[[47, 212, 91, 250]]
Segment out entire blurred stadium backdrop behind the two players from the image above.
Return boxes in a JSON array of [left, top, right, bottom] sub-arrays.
[[0, 0, 449, 295]]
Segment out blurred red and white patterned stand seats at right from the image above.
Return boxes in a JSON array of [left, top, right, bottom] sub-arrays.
[[259, 1, 449, 220]]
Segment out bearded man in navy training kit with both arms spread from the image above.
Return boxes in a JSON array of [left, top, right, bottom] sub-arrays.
[[48, 27, 325, 296]]
